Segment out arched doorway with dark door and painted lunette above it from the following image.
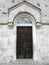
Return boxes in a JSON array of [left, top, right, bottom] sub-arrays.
[[14, 12, 36, 59]]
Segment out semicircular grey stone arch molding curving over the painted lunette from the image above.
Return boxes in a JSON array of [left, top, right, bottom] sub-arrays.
[[13, 11, 36, 24]]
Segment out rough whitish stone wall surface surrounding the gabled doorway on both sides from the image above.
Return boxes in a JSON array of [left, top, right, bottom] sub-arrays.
[[0, 0, 49, 65]]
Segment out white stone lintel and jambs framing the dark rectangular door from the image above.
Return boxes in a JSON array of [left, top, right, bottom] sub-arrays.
[[16, 24, 36, 60]]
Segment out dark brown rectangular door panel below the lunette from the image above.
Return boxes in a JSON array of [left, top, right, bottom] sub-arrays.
[[16, 26, 33, 59]]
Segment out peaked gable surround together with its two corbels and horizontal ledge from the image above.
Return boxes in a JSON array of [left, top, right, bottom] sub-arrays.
[[0, 0, 49, 29]]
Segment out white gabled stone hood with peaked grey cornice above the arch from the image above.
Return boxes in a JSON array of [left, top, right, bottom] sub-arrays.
[[8, 1, 41, 22]]
